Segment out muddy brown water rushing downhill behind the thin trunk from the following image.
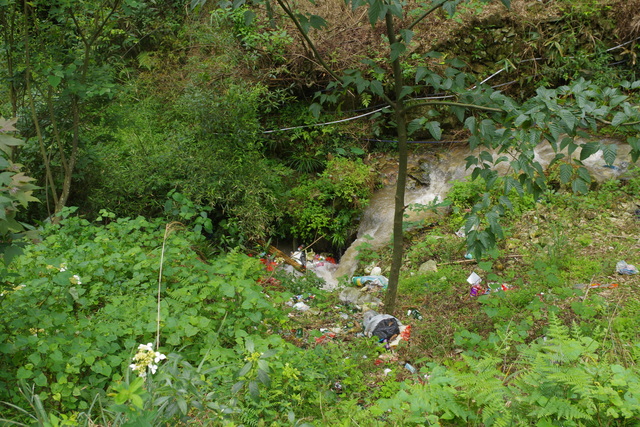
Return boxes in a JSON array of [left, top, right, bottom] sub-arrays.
[[314, 141, 631, 290]]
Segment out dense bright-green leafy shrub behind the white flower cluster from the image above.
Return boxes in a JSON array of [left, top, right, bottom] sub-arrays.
[[0, 212, 283, 410]]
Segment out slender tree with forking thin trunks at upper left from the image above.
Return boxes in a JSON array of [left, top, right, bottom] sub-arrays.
[[0, 0, 129, 218]]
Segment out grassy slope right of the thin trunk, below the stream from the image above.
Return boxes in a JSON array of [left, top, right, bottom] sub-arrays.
[[290, 168, 640, 382]]
